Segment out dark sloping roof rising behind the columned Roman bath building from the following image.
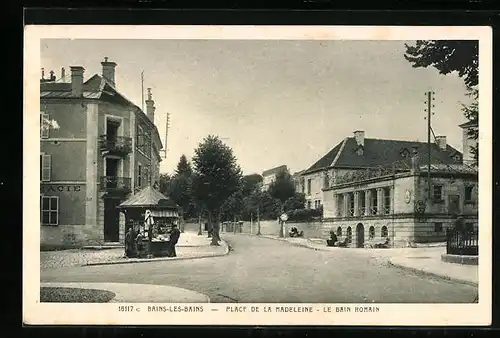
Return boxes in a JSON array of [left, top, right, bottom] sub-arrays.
[[304, 137, 462, 173]]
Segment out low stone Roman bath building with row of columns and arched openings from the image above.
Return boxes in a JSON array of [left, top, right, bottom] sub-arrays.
[[323, 157, 478, 247]]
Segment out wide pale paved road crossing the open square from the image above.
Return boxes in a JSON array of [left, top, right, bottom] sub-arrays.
[[41, 234, 477, 303]]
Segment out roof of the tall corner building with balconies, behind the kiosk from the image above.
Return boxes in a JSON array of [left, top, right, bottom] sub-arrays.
[[40, 74, 163, 149]]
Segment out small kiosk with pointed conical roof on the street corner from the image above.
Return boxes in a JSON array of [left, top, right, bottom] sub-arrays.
[[118, 186, 179, 258]]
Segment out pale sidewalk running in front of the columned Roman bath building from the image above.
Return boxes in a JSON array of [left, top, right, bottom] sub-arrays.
[[248, 235, 478, 286]]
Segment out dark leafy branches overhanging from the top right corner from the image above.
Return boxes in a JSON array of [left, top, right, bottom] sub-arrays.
[[404, 40, 479, 165]]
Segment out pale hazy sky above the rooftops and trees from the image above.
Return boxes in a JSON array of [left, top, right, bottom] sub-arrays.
[[41, 39, 468, 174]]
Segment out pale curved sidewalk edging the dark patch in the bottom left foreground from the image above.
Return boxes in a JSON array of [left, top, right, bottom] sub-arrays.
[[40, 283, 210, 303]]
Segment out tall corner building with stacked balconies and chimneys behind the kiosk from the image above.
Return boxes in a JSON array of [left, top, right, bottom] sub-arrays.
[[40, 58, 162, 245]]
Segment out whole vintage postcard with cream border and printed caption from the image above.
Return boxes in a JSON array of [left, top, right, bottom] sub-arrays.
[[23, 25, 492, 326]]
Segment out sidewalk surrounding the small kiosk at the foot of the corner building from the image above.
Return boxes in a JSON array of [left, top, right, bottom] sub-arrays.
[[40, 232, 229, 269]]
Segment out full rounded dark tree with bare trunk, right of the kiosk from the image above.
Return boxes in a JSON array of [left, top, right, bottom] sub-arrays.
[[192, 135, 242, 245]]
